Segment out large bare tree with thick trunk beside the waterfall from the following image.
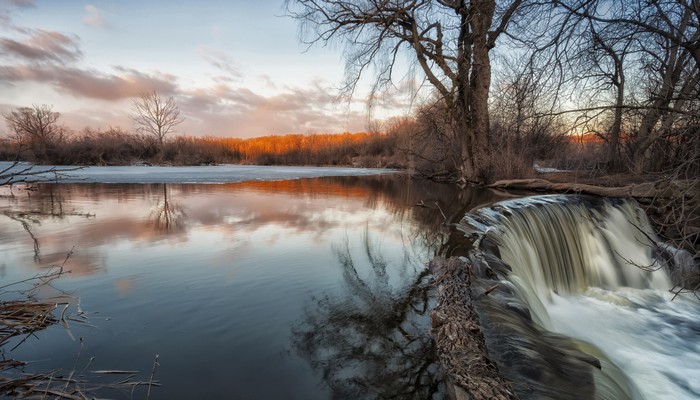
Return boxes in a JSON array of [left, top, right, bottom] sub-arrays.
[[287, 0, 523, 182]]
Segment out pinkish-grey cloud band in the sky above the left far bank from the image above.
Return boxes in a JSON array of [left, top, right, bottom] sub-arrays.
[[0, 4, 393, 137]]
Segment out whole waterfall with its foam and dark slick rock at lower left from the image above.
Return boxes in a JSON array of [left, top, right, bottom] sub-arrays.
[[460, 195, 700, 399]]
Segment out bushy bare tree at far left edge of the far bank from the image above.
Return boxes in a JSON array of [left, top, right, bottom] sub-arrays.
[[2, 105, 65, 161]]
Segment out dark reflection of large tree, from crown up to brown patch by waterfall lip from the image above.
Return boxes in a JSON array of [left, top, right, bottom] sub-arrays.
[[292, 180, 506, 399]]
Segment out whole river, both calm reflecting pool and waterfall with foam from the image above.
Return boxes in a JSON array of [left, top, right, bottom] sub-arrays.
[[0, 166, 700, 400]]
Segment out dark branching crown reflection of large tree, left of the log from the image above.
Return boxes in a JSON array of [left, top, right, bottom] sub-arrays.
[[292, 230, 444, 398]]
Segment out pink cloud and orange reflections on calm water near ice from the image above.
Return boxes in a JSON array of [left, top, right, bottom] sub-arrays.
[[0, 179, 388, 273]]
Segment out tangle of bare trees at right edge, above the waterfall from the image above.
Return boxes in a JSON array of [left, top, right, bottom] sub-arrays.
[[519, 0, 700, 173]]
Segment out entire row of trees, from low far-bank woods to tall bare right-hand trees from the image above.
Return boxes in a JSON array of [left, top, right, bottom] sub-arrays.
[[3, 0, 700, 183]]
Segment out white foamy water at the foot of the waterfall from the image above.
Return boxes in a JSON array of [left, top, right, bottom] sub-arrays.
[[546, 288, 700, 400]]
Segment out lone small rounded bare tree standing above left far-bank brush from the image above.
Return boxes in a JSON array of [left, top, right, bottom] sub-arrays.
[[131, 91, 184, 145]]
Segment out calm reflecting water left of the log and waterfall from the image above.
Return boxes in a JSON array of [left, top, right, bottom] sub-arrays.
[[0, 174, 504, 399]]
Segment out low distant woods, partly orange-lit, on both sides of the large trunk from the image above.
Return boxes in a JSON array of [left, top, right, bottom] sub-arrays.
[[0, 104, 604, 180]]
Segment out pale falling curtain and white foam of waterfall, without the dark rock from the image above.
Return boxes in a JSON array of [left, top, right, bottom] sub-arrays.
[[468, 196, 700, 400]]
